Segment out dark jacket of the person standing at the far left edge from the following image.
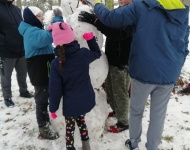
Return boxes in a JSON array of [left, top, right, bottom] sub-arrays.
[[0, 0, 24, 58]]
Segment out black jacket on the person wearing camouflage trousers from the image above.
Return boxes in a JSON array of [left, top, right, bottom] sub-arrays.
[[94, 19, 134, 69]]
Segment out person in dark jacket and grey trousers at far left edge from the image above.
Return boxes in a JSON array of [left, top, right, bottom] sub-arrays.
[[0, 0, 33, 107]]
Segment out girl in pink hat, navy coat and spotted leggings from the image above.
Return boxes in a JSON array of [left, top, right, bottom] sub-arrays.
[[48, 22, 101, 150]]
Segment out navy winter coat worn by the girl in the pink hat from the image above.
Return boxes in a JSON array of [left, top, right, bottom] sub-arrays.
[[49, 38, 101, 117]]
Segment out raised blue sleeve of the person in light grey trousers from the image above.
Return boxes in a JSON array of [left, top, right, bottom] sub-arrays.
[[94, 2, 136, 28]]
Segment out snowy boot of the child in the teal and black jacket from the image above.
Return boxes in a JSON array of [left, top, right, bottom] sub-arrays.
[[38, 123, 59, 140]]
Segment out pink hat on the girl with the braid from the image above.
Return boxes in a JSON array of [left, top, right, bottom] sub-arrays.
[[47, 22, 75, 46]]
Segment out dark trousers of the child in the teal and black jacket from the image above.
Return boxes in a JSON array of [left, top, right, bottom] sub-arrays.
[[34, 86, 49, 127]]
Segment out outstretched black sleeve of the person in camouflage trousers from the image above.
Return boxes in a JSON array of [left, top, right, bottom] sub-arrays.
[[94, 19, 133, 41]]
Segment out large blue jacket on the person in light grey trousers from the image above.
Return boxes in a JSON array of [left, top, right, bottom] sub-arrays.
[[94, 0, 189, 84]]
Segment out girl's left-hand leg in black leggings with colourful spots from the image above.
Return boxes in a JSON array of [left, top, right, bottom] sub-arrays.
[[65, 117, 75, 150]]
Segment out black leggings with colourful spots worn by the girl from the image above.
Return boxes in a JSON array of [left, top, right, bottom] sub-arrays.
[[65, 115, 89, 150]]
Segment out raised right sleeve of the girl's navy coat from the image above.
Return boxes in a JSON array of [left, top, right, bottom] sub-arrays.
[[81, 37, 101, 63]]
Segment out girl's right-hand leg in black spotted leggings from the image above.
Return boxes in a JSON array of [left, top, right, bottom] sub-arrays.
[[76, 115, 89, 141]]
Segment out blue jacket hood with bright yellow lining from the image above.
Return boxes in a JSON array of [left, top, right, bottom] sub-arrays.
[[142, 0, 189, 24]]
